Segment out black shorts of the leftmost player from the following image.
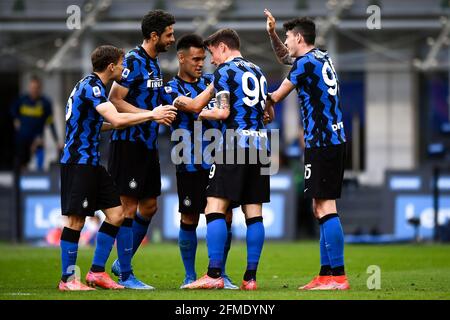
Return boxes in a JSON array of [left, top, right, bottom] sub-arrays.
[[61, 164, 121, 216]]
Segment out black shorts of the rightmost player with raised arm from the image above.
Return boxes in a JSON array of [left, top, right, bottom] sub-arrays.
[[304, 143, 346, 200]]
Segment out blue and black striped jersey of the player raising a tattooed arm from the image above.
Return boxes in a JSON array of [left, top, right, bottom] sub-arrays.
[[288, 48, 345, 148]]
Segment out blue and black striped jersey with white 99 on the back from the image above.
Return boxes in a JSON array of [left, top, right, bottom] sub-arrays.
[[214, 57, 267, 150]]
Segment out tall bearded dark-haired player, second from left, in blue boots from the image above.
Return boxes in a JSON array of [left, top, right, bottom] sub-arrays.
[[108, 10, 175, 290]]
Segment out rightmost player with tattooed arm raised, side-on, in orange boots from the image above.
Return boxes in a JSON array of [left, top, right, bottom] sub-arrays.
[[265, 9, 350, 290]]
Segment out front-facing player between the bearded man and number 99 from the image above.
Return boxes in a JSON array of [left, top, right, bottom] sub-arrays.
[[164, 34, 238, 289]]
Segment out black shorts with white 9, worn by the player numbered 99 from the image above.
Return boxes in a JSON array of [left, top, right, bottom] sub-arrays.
[[206, 164, 270, 207]]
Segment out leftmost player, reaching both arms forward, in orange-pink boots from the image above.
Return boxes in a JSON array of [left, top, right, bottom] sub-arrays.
[[58, 46, 176, 291]]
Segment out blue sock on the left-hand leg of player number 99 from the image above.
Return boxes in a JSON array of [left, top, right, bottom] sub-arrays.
[[206, 212, 227, 278]]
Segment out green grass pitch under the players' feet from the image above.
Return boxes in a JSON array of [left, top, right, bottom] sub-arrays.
[[0, 241, 450, 300]]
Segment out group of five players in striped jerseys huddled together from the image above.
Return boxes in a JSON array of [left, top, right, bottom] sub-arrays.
[[58, 10, 350, 291]]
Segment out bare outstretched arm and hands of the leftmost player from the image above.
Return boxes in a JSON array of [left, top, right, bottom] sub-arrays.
[[96, 101, 176, 128]]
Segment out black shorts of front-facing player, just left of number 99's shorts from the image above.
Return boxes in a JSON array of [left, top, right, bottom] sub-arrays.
[[177, 170, 209, 214]]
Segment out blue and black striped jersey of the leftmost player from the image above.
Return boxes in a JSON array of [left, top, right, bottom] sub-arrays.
[[61, 73, 107, 166]]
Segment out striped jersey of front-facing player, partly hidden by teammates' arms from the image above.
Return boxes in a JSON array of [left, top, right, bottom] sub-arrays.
[[163, 74, 221, 172]]
